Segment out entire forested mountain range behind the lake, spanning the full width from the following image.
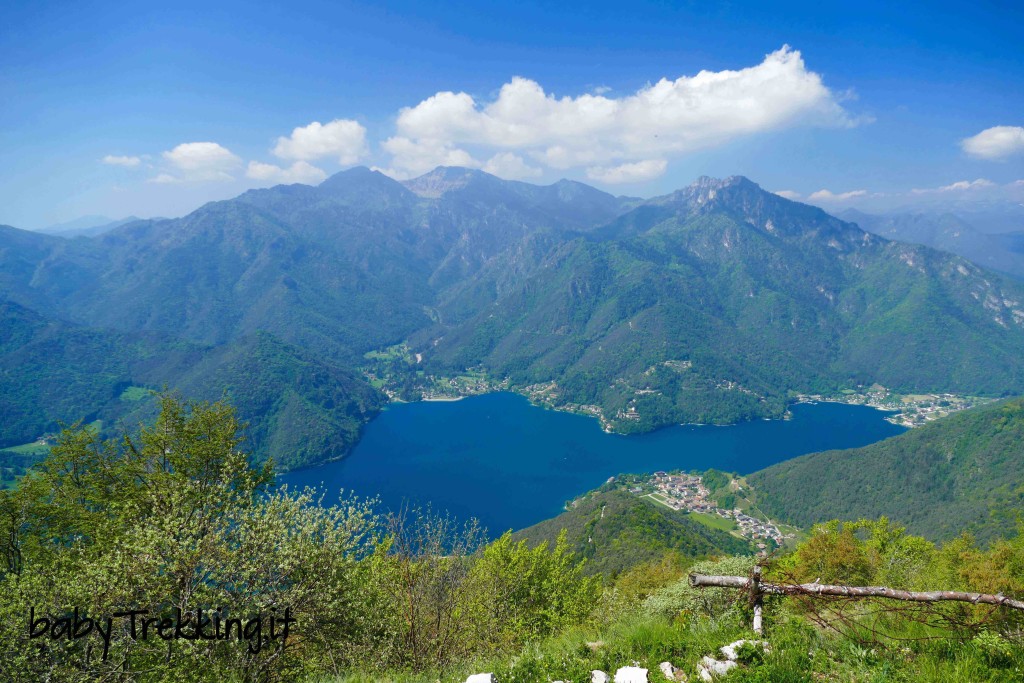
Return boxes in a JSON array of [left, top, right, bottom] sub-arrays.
[[0, 168, 1024, 467]]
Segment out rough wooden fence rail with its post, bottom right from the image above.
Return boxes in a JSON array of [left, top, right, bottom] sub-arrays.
[[690, 566, 1024, 634]]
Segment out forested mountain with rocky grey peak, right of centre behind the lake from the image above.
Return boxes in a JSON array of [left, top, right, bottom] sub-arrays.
[[419, 178, 1024, 430]]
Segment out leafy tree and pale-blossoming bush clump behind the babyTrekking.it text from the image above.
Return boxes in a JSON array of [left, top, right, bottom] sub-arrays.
[[0, 395, 375, 681]]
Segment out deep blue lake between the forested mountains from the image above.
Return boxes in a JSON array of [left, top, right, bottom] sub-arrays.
[[280, 393, 904, 537]]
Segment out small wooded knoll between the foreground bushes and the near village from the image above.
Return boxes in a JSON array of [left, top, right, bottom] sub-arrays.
[[513, 490, 751, 575]]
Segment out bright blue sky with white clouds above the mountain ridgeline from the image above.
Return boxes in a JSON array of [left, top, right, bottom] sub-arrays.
[[0, 1, 1024, 227]]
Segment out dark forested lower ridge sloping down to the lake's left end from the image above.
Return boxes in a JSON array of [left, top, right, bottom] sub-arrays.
[[0, 302, 385, 467]]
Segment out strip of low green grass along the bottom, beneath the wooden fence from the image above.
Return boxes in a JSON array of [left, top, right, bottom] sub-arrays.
[[308, 614, 1024, 683]]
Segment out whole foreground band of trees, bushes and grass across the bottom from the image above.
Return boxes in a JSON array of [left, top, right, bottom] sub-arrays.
[[0, 396, 1024, 683]]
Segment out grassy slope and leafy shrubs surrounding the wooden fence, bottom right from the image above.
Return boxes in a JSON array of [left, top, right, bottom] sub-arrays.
[[327, 519, 1024, 683]]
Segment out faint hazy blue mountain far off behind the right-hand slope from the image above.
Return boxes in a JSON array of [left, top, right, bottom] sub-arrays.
[[838, 209, 1024, 278]]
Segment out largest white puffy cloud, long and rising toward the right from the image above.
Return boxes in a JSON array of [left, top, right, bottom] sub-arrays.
[[382, 46, 859, 183]]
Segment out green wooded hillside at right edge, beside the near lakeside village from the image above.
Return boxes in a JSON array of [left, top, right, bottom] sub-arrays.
[[748, 398, 1024, 540]]
